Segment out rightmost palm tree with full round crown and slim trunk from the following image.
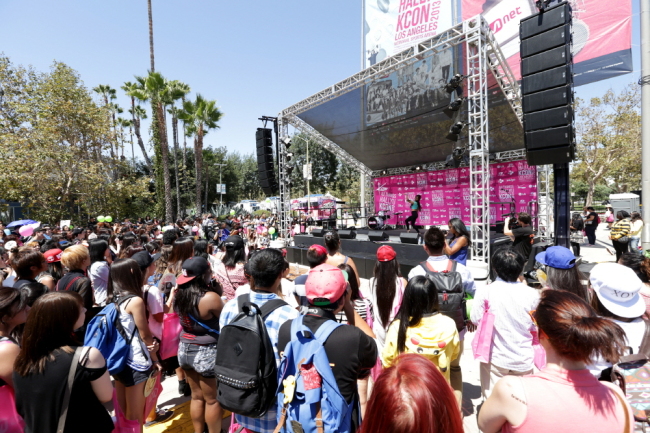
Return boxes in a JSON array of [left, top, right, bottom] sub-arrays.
[[178, 95, 223, 215]]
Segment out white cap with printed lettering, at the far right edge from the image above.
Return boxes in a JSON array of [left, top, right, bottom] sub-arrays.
[[589, 263, 645, 319]]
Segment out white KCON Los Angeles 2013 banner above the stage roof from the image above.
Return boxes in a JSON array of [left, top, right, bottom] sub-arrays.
[[364, 0, 453, 68]]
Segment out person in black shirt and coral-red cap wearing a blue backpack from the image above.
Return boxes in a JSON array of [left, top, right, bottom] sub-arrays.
[[278, 264, 377, 431]]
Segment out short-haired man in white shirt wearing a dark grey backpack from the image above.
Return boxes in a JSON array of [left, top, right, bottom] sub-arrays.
[[409, 227, 476, 406]]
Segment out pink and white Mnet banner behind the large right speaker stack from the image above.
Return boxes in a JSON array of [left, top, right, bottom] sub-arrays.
[[462, 0, 632, 85]]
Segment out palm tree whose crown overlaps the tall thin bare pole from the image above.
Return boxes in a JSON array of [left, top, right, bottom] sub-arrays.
[[133, 72, 174, 221]]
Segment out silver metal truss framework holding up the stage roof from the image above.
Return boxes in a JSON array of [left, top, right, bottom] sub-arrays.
[[278, 15, 525, 262]]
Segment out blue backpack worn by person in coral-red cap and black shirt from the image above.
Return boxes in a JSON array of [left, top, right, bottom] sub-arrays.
[[276, 316, 357, 433]]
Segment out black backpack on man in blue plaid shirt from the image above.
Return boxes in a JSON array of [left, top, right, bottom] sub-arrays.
[[214, 294, 287, 418]]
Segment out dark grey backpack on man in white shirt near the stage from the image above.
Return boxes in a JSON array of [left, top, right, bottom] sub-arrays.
[[420, 260, 467, 332]]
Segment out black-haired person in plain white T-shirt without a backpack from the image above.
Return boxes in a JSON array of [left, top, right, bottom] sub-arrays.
[[471, 247, 539, 398]]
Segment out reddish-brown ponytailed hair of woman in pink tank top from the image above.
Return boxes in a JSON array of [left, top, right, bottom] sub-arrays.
[[535, 290, 626, 363]]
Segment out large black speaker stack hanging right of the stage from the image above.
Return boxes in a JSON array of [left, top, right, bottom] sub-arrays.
[[519, 2, 575, 165]]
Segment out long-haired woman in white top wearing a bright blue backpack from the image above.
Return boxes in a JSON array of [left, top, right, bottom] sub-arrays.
[[108, 259, 162, 426]]
